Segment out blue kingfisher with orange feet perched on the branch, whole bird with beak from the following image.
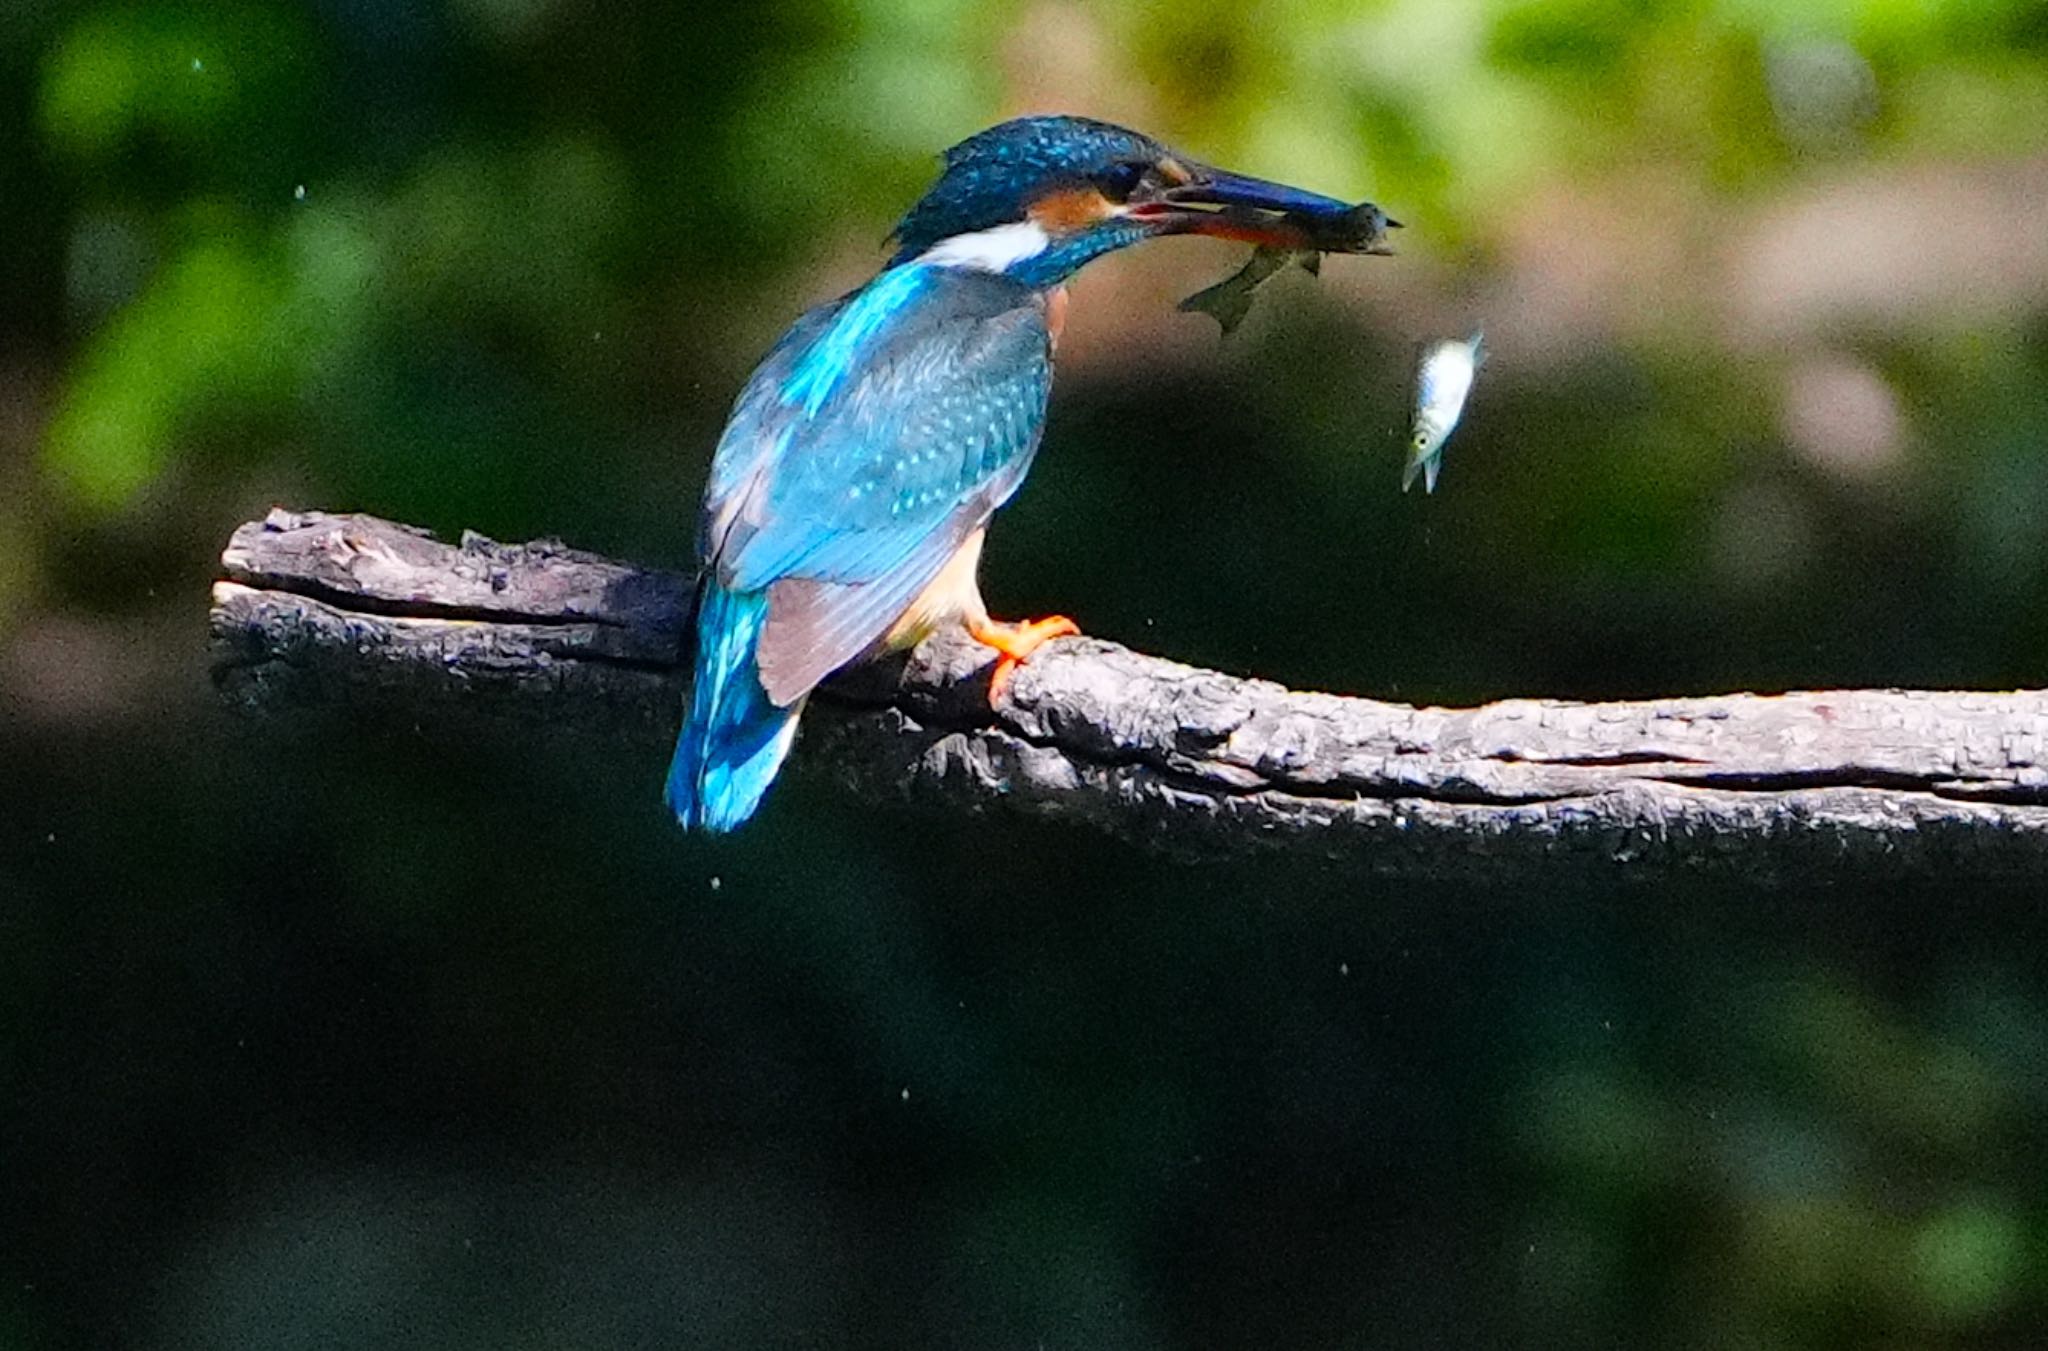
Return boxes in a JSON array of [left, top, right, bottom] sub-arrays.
[[666, 117, 1350, 833]]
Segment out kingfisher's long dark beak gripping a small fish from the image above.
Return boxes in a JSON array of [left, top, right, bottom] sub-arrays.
[[1135, 166, 1401, 254]]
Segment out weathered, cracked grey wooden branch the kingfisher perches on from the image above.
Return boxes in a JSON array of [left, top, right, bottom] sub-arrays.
[[213, 512, 2048, 882]]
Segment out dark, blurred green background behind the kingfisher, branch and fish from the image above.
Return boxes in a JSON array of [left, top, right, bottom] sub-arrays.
[[0, 0, 2048, 1351]]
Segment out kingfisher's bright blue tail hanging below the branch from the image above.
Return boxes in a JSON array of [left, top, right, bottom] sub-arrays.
[[666, 579, 803, 833]]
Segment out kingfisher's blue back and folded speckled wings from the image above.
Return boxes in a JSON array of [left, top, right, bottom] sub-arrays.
[[707, 268, 1053, 702]]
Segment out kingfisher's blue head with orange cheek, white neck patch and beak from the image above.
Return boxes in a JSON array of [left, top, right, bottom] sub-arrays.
[[895, 117, 1384, 287]]
